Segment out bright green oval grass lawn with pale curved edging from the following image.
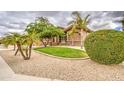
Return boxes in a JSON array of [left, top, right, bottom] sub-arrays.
[[34, 47, 87, 58]]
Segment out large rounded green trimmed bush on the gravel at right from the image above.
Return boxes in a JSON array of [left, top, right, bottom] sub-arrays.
[[84, 30, 124, 64]]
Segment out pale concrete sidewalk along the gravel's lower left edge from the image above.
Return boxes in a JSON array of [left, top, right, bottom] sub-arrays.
[[0, 57, 51, 81]]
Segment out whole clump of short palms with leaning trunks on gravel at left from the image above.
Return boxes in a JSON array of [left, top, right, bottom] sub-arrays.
[[2, 32, 35, 60]]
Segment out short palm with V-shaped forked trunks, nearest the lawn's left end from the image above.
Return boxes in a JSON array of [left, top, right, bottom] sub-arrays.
[[16, 31, 36, 60]]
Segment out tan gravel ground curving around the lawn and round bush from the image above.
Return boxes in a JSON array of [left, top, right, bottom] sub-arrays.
[[0, 50, 124, 80]]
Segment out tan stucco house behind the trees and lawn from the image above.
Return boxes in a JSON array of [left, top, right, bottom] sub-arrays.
[[39, 26, 92, 46]]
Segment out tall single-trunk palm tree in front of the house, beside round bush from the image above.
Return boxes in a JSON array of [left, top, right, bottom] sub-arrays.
[[69, 11, 90, 49]]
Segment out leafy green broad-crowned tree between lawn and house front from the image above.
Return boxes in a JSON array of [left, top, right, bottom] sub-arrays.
[[33, 17, 64, 47]]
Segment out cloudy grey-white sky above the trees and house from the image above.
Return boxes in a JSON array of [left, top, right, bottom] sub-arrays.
[[0, 11, 124, 36]]
